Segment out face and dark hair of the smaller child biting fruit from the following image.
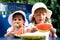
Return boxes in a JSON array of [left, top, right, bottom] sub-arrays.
[[13, 13, 25, 24]]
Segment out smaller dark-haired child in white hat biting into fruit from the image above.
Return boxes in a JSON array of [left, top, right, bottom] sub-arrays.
[[4, 10, 28, 37]]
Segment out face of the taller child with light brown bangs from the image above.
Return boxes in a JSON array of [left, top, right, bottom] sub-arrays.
[[34, 10, 46, 23]]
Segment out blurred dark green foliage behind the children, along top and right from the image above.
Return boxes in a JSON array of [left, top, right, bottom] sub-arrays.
[[0, 0, 60, 36]]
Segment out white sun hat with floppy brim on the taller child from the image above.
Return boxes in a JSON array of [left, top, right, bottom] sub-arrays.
[[29, 2, 52, 21]]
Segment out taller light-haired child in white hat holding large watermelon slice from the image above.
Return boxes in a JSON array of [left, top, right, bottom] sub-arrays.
[[28, 2, 57, 37]]
